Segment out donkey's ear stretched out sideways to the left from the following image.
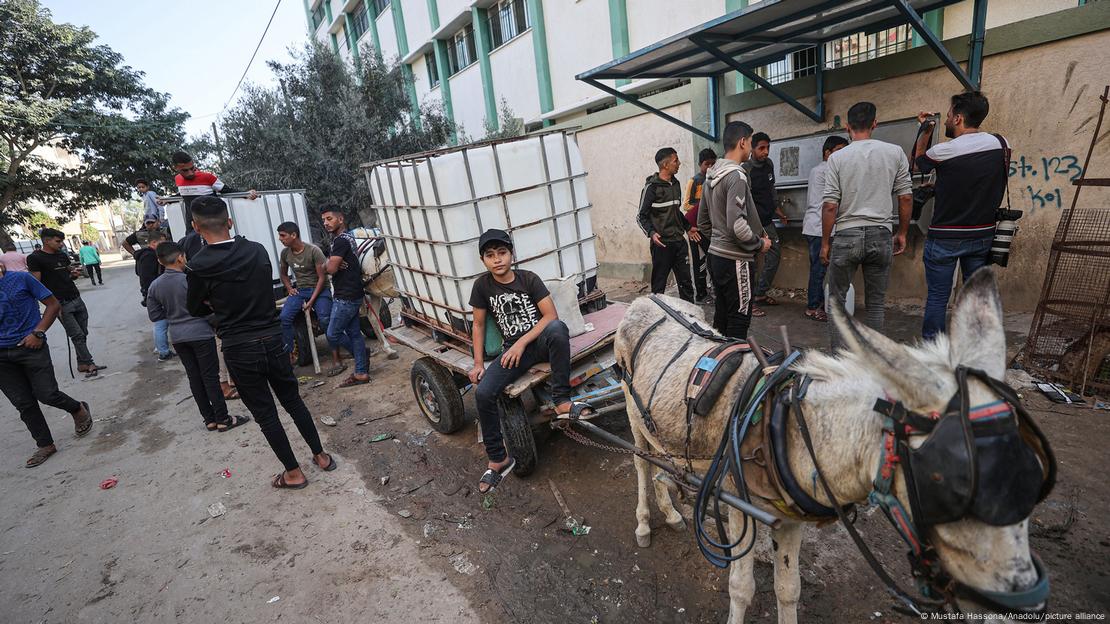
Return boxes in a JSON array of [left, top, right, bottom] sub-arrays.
[[831, 300, 946, 405]]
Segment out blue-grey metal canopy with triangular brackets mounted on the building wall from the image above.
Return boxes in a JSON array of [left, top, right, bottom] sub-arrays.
[[576, 0, 987, 141]]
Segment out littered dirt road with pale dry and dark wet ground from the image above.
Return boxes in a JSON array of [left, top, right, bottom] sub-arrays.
[[0, 270, 1110, 624]]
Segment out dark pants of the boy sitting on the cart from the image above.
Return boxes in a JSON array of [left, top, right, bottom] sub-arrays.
[[474, 320, 571, 462]]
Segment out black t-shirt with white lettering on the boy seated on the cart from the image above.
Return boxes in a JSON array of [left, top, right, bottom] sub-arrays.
[[471, 269, 551, 349]]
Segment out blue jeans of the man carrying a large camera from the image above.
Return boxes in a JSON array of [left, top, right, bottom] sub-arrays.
[[921, 236, 993, 340]]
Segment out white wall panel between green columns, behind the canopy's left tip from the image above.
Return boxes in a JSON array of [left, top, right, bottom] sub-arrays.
[[544, 0, 617, 110]]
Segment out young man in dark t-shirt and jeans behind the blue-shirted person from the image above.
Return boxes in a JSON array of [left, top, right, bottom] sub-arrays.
[[27, 228, 107, 378]]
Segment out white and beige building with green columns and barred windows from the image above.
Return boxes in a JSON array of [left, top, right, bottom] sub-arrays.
[[304, 0, 1110, 310]]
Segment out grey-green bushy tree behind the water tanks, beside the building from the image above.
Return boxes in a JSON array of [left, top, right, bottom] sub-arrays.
[[204, 42, 452, 222]]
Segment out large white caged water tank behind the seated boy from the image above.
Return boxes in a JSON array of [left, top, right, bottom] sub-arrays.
[[363, 132, 597, 332]]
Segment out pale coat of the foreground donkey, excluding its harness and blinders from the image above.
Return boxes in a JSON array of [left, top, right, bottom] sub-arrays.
[[616, 270, 1047, 624]]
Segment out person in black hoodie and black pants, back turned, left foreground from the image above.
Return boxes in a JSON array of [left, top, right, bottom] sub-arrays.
[[185, 197, 336, 490]]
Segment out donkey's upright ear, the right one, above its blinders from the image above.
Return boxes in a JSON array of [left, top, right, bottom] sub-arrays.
[[948, 268, 1006, 379]]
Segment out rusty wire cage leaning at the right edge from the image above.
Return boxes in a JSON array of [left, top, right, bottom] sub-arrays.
[[1021, 87, 1110, 392]]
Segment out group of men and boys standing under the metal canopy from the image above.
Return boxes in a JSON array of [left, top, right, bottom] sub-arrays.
[[637, 91, 1010, 348]]
